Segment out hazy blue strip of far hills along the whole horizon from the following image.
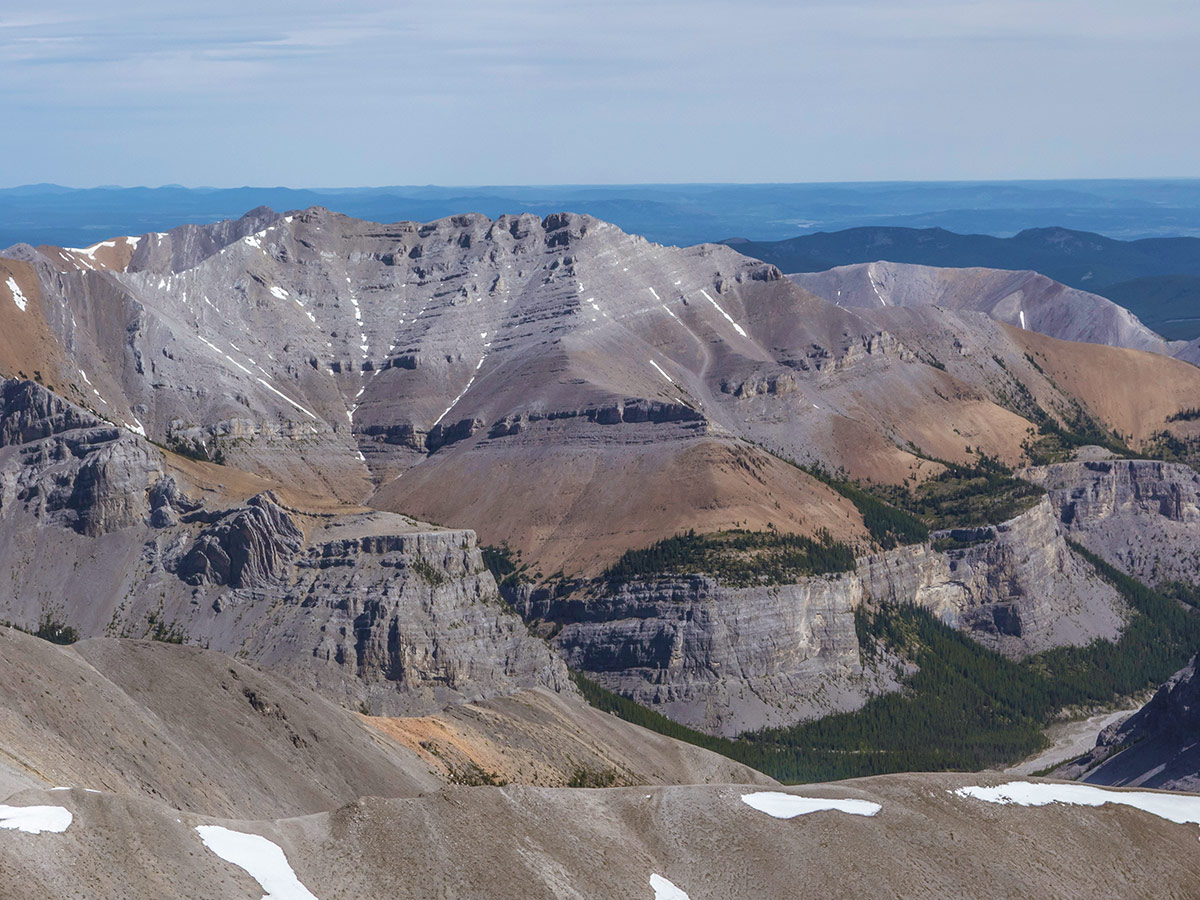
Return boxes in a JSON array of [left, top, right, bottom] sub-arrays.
[[7, 179, 1200, 248]]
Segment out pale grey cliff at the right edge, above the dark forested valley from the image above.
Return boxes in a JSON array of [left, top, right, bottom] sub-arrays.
[[1022, 460, 1200, 584]]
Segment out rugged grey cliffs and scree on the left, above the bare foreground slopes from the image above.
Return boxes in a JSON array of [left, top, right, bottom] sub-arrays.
[[0, 382, 572, 714]]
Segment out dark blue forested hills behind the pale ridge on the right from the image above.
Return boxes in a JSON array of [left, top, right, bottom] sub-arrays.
[[725, 228, 1200, 341]]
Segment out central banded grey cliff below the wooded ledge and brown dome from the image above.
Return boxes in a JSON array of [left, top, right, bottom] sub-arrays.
[[524, 576, 894, 736]]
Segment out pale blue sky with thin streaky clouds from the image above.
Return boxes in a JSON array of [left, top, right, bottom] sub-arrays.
[[0, 0, 1200, 187]]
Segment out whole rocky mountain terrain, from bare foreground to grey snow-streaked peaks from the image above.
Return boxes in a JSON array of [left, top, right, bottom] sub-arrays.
[[0, 206, 1200, 900]]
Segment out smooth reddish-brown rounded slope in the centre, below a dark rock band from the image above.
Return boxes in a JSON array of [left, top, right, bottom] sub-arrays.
[[372, 434, 865, 575]]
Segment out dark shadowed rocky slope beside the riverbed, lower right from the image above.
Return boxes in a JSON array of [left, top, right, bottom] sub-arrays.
[[1052, 658, 1200, 791]]
